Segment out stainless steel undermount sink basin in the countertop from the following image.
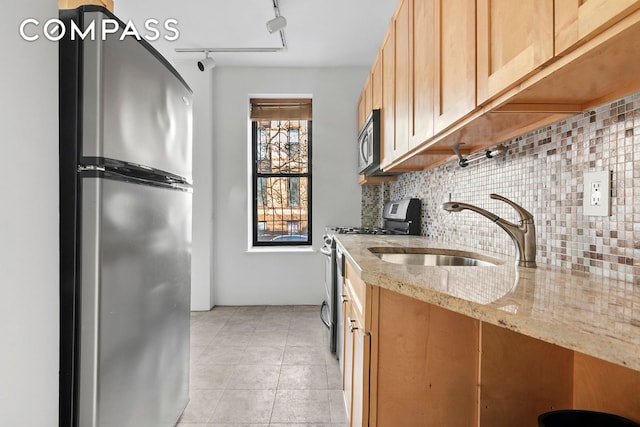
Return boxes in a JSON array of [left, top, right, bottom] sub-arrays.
[[369, 247, 503, 267]]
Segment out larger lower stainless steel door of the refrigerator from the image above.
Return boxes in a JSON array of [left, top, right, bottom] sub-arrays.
[[78, 178, 191, 427]]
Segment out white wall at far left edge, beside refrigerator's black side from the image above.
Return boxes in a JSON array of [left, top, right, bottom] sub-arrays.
[[0, 0, 59, 427]]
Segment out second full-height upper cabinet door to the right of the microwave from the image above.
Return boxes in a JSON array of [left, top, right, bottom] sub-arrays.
[[393, 0, 412, 158]]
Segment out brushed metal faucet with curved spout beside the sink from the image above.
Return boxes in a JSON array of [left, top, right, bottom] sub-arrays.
[[442, 194, 536, 268]]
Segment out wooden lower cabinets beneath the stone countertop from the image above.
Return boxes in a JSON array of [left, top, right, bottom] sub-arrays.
[[343, 268, 640, 427]]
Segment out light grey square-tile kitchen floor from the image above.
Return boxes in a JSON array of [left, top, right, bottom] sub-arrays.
[[178, 306, 347, 427]]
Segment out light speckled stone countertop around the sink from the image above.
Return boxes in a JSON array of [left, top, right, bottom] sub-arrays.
[[336, 234, 640, 371]]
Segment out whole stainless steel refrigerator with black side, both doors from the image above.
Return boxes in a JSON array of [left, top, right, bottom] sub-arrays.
[[59, 6, 192, 427]]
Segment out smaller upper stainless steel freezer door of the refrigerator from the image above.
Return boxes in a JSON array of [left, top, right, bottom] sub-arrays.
[[81, 11, 192, 181]]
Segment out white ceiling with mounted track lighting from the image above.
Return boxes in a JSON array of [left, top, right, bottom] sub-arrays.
[[115, 0, 397, 67]]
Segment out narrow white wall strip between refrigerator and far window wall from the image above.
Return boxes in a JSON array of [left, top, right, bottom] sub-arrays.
[[176, 61, 215, 311]]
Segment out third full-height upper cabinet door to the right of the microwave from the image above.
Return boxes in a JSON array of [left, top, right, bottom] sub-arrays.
[[409, 0, 435, 148]]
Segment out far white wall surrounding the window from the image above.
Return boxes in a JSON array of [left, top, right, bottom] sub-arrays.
[[210, 67, 368, 305]]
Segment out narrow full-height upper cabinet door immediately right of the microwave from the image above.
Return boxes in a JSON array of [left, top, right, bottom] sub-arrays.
[[380, 28, 396, 168]]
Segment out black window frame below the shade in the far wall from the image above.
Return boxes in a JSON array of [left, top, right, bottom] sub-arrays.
[[250, 119, 313, 248]]
